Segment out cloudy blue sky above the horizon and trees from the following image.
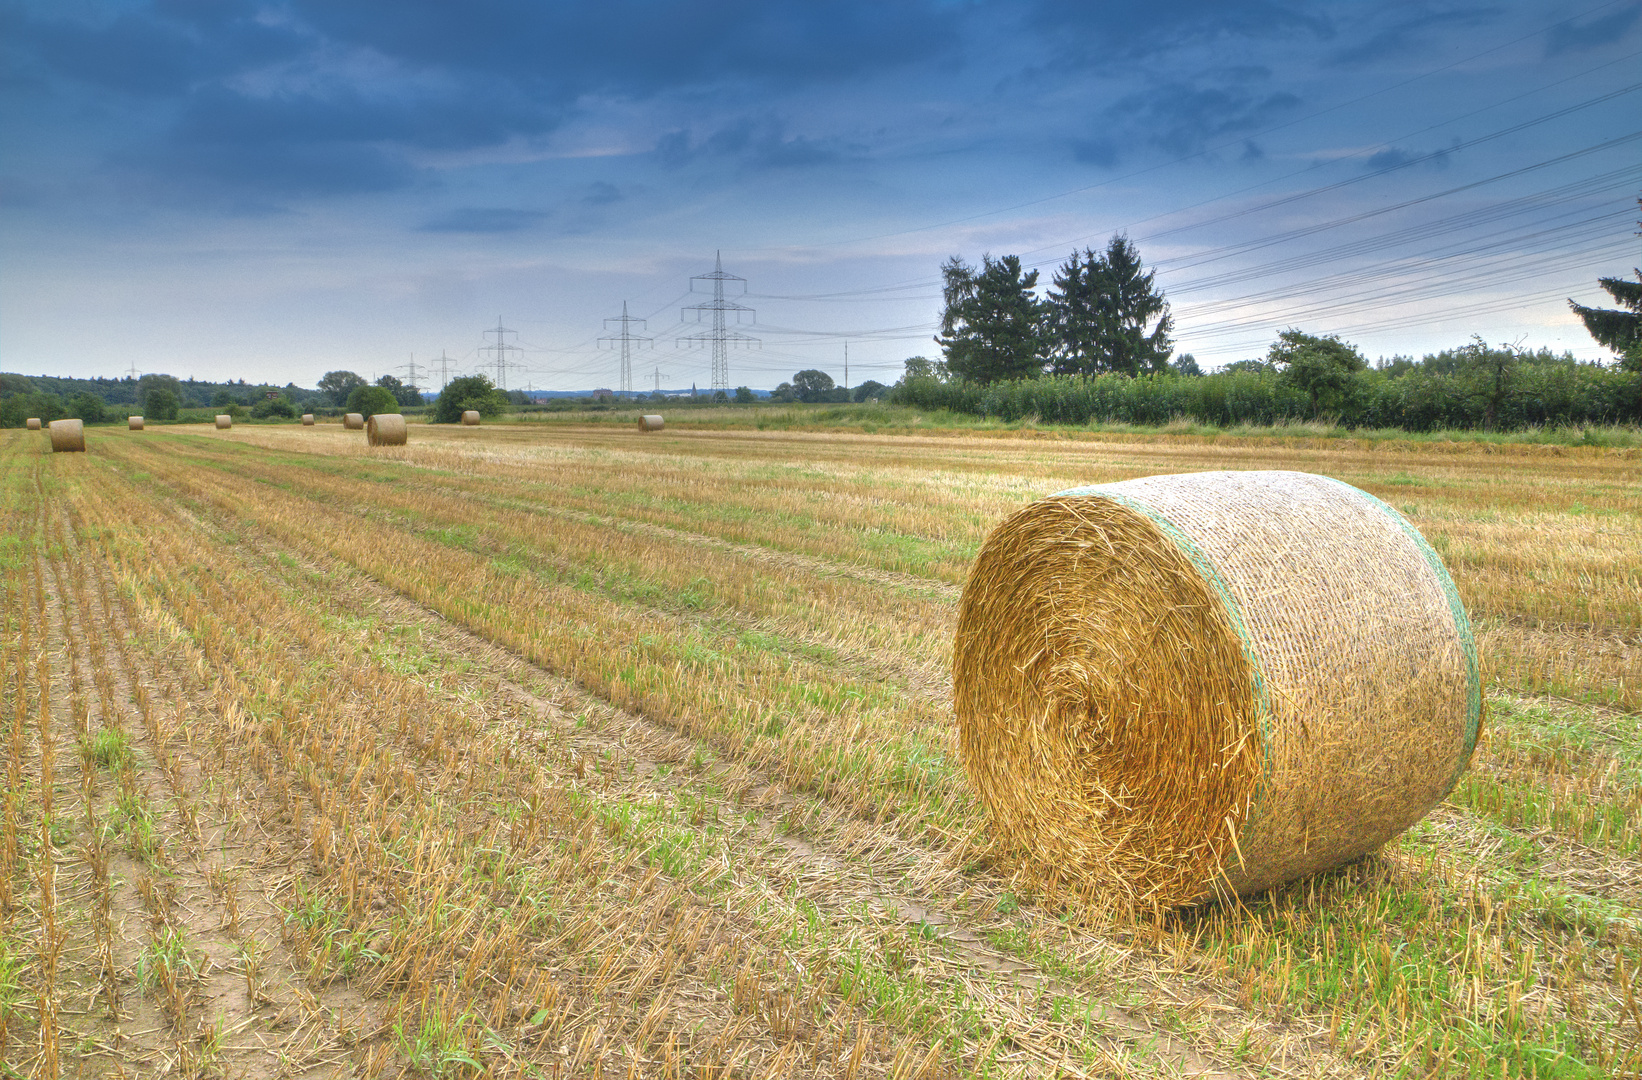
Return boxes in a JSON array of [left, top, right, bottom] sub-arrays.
[[0, 0, 1642, 389]]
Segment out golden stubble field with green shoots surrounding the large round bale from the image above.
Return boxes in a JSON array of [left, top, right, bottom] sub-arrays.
[[0, 425, 1642, 1078]]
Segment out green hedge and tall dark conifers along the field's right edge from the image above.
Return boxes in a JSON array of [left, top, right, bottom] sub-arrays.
[[890, 215, 1642, 432]]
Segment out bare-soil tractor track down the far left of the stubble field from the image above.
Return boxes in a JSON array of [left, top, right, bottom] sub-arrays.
[[25, 492, 374, 1080]]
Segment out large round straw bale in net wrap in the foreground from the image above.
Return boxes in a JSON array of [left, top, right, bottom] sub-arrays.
[[952, 473, 1481, 908]]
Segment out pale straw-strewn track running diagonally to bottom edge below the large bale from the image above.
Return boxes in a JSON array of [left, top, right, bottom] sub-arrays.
[[166, 504, 1358, 1080]]
